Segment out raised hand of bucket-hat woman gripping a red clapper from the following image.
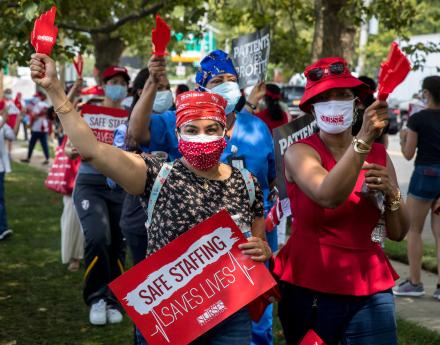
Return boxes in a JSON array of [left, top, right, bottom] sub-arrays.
[[357, 101, 388, 144]]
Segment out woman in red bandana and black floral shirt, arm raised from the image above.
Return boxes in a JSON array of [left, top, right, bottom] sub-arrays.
[[30, 54, 271, 345]]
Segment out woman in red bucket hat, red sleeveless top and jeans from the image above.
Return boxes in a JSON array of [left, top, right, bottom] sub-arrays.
[[275, 58, 408, 345]]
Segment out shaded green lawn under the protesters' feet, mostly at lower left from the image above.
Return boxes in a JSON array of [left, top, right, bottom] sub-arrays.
[[0, 164, 440, 345]]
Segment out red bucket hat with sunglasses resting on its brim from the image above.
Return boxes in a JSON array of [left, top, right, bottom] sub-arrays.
[[299, 57, 370, 113]]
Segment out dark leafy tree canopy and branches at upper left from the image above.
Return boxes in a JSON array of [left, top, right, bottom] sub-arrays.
[[0, 0, 205, 70]]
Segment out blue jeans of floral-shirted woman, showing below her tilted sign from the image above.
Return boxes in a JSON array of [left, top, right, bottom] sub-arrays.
[[136, 308, 251, 345]]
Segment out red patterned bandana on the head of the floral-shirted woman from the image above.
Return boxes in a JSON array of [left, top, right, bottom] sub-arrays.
[[176, 91, 227, 128]]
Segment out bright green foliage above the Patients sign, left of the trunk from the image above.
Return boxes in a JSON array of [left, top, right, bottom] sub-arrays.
[[209, 0, 314, 71]]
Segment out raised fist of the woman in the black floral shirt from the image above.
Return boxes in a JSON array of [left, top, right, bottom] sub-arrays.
[[29, 53, 59, 90]]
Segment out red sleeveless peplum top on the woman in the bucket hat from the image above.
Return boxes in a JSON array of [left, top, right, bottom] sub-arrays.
[[274, 134, 399, 296]]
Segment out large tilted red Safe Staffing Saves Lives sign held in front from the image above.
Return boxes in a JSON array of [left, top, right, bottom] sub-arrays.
[[110, 211, 276, 345]]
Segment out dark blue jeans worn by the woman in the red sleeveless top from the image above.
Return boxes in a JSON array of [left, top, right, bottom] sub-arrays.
[[278, 282, 397, 345]]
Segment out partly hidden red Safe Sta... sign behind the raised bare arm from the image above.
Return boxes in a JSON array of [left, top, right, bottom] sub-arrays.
[[81, 104, 128, 145]]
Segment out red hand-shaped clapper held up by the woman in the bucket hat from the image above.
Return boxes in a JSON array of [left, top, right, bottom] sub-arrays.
[[378, 42, 411, 101]]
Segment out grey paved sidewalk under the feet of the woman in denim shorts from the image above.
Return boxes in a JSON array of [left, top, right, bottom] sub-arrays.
[[391, 261, 440, 333]]
